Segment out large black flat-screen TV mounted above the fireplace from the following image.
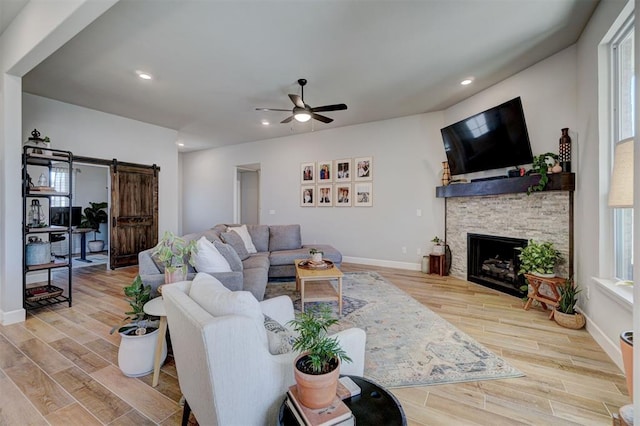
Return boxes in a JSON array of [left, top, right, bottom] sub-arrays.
[[440, 97, 533, 175]]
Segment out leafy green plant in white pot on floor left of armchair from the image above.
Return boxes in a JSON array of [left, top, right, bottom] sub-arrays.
[[111, 275, 167, 377]]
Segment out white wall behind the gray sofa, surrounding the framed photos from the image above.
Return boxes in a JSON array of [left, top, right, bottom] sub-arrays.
[[182, 113, 445, 269]]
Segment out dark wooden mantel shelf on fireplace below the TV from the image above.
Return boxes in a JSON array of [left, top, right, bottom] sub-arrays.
[[436, 173, 576, 198]]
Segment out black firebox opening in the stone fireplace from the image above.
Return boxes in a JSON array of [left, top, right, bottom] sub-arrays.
[[467, 234, 528, 297]]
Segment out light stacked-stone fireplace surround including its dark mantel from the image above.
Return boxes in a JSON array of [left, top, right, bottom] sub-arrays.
[[436, 173, 574, 292]]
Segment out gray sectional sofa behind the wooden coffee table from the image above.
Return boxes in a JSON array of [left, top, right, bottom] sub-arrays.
[[138, 224, 342, 300]]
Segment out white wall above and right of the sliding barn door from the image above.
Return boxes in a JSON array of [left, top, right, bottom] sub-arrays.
[[22, 93, 179, 235]]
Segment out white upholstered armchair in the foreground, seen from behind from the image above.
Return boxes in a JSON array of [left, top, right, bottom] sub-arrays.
[[162, 274, 366, 425]]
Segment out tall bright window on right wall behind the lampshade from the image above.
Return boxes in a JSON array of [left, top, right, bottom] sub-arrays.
[[610, 20, 637, 280]]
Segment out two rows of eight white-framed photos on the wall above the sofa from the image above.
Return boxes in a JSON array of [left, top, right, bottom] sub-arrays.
[[300, 157, 373, 207]]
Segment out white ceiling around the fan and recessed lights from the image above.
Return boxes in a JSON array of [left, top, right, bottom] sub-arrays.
[[21, 0, 597, 150]]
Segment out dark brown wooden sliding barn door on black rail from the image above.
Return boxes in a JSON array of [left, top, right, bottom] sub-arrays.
[[110, 161, 159, 269]]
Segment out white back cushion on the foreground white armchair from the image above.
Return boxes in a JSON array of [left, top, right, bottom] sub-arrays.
[[189, 273, 264, 327]]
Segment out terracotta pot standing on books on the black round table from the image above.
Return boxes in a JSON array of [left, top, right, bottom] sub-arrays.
[[293, 353, 340, 408]]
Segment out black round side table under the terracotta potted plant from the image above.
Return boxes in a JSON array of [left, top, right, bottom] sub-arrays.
[[278, 376, 407, 426]]
